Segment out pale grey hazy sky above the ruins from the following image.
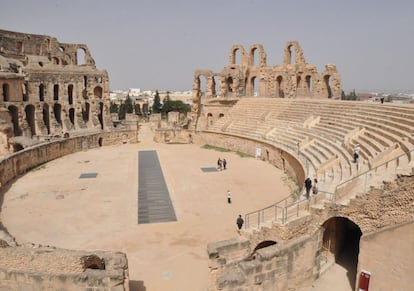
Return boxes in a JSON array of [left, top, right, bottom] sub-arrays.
[[0, 0, 414, 92]]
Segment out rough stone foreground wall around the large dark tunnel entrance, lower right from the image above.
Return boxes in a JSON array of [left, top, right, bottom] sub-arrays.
[[208, 175, 414, 290]]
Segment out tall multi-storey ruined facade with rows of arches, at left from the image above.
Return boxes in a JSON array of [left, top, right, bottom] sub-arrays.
[[0, 30, 112, 157]]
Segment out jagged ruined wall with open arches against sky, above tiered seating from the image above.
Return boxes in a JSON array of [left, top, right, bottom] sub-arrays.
[[193, 41, 342, 103]]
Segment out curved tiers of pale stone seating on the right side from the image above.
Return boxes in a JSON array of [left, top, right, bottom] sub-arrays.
[[205, 98, 414, 189]]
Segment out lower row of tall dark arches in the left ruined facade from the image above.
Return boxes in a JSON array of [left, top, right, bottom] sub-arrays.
[[7, 102, 104, 137]]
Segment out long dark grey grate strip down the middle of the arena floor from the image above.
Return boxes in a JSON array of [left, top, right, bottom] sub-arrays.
[[138, 151, 177, 224]]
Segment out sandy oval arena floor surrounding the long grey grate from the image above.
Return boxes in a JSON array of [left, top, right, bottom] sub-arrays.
[[1, 128, 296, 291]]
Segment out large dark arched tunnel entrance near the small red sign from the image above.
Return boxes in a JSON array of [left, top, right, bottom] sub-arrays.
[[322, 217, 362, 288]]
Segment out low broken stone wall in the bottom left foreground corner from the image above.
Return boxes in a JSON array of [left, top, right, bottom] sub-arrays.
[[0, 246, 129, 291]]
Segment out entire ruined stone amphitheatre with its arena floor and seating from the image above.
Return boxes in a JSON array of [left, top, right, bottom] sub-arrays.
[[0, 30, 414, 291]]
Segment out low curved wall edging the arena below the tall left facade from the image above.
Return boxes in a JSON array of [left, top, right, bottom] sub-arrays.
[[0, 130, 137, 188]]
